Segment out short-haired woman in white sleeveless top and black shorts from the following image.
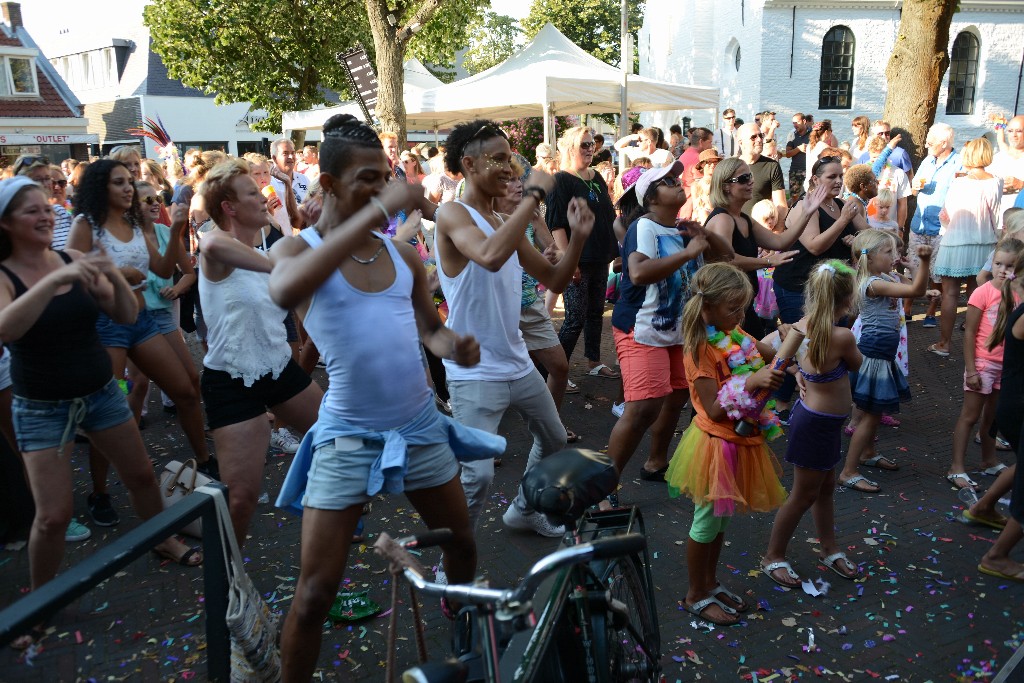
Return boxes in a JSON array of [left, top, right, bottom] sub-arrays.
[[192, 159, 324, 546]]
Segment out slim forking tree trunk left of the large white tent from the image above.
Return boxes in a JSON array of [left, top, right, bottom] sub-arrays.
[[367, 0, 406, 145]]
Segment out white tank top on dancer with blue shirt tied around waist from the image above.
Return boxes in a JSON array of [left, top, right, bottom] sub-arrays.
[[296, 232, 433, 430]]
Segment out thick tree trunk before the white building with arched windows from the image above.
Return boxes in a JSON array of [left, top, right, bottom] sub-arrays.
[[882, 0, 957, 168]]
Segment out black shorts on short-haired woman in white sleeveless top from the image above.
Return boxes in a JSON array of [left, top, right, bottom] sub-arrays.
[[200, 359, 311, 429]]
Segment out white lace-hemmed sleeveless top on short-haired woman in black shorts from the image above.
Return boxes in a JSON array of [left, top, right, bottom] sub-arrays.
[[197, 252, 292, 387]]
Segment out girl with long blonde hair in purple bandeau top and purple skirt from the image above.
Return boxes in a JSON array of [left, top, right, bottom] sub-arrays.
[[761, 260, 863, 588]]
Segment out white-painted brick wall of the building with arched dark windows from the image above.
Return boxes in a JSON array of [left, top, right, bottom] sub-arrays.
[[639, 0, 1024, 169]]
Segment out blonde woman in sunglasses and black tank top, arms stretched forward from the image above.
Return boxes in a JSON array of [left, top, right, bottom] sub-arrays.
[[705, 157, 806, 339]]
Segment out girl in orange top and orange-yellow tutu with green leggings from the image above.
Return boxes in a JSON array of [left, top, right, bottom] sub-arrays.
[[666, 263, 785, 626]]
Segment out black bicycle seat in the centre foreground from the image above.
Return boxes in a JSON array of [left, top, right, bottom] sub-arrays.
[[522, 449, 618, 524]]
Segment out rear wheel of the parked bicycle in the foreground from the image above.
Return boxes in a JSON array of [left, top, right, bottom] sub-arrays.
[[606, 556, 662, 683]]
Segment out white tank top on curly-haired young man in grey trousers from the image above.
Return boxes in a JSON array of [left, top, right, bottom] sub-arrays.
[[435, 202, 534, 382]]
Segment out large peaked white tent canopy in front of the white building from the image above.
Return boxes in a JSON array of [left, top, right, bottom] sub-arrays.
[[406, 24, 719, 136]]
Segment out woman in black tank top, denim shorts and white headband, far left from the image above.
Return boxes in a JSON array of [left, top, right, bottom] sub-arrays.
[[0, 177, 202, 647]]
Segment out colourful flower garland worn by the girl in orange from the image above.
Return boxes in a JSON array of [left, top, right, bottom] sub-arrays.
[[708, 325, 782, 441]]
